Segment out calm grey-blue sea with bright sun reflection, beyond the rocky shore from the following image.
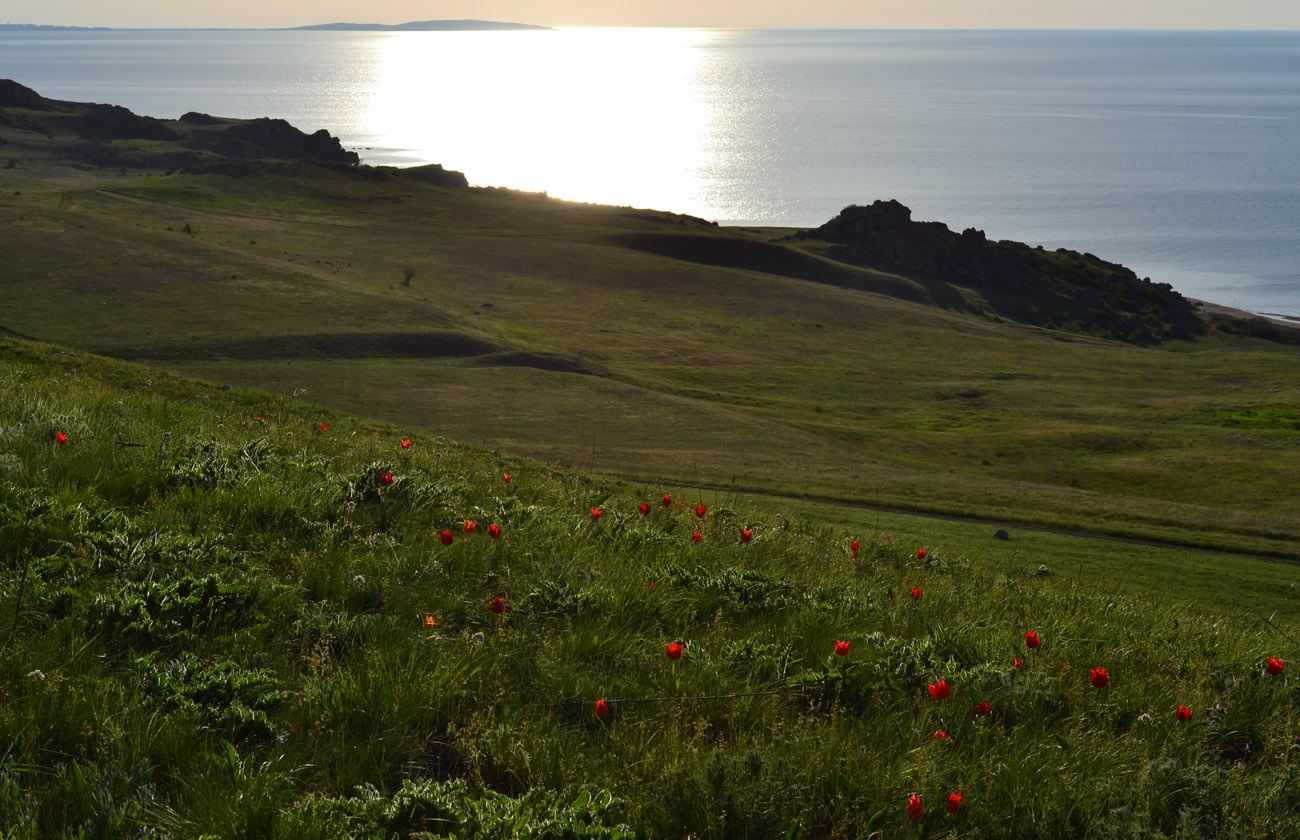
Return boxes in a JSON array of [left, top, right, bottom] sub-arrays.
[[0, 29, 1300, 316]]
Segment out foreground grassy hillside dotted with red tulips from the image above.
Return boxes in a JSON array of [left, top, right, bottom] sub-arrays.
[[0, 341, 1300, 840]]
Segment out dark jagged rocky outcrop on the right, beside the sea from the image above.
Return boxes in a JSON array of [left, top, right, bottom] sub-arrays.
[[798, 200, 1204, 343]]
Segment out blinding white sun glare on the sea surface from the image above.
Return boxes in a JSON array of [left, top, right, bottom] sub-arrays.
[[361, 29, 719, 209]]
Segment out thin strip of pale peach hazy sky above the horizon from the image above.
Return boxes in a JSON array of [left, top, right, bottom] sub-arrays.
[[0, 0, 1300, 30]]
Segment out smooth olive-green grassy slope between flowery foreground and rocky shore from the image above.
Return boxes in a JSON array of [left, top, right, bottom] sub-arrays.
[[0, 150, 1300, 559]]
